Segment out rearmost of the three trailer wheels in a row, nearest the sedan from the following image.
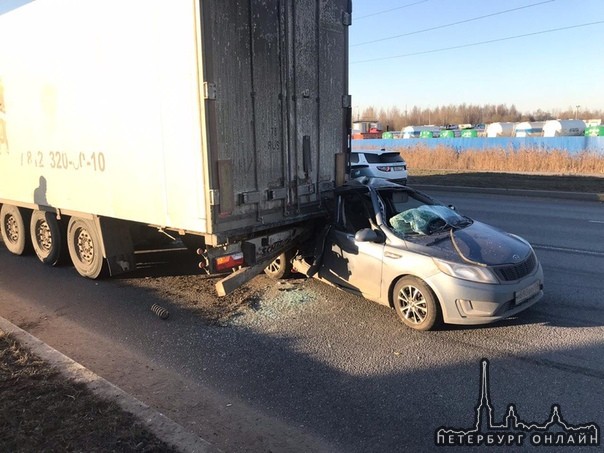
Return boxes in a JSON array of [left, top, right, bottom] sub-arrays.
[[67, 217, 105, 279]]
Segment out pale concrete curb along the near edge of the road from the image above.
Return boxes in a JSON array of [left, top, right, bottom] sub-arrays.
[[0, 316, 220, 453]]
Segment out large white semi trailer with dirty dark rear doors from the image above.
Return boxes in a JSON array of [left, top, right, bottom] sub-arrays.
[[0, 0, 351, 294]]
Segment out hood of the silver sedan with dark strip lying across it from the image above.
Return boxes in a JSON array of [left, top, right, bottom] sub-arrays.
[[406, 221, 531, 266]]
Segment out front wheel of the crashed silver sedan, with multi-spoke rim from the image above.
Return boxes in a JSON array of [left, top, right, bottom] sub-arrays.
[[392, 276, 441, 330]]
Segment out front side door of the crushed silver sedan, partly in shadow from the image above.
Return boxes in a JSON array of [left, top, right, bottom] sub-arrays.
[[319, 192, 384, 299]]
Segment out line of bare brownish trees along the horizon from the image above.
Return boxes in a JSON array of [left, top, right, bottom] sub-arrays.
[[354, 104, 604, 131]]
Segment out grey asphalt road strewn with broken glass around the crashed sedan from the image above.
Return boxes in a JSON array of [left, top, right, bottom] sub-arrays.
[[0, 192, 604, 452]]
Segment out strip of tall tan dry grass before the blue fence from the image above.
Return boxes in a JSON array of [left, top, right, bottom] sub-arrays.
[[397, 146, 604, 176]]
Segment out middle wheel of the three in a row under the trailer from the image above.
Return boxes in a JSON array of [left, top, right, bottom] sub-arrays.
[[29, 211, 66, 266]]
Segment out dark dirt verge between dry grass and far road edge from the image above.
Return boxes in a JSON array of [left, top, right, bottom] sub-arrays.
[[409, 170, 604, 193]]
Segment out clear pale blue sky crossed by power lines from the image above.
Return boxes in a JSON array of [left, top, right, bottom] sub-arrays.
[[350, 0, 604, 117]]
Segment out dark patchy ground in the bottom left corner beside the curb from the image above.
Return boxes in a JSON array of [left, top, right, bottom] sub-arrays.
[[0, 332, 177, 452]]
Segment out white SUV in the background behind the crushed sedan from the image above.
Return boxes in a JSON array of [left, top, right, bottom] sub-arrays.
[[350, 149, 407, 185]]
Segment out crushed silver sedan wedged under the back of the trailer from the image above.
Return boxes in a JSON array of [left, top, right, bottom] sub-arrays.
[[294, 179, 543, 330]]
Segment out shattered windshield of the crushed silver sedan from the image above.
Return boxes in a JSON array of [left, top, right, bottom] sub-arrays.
[[379, 190, 472, 236]]
